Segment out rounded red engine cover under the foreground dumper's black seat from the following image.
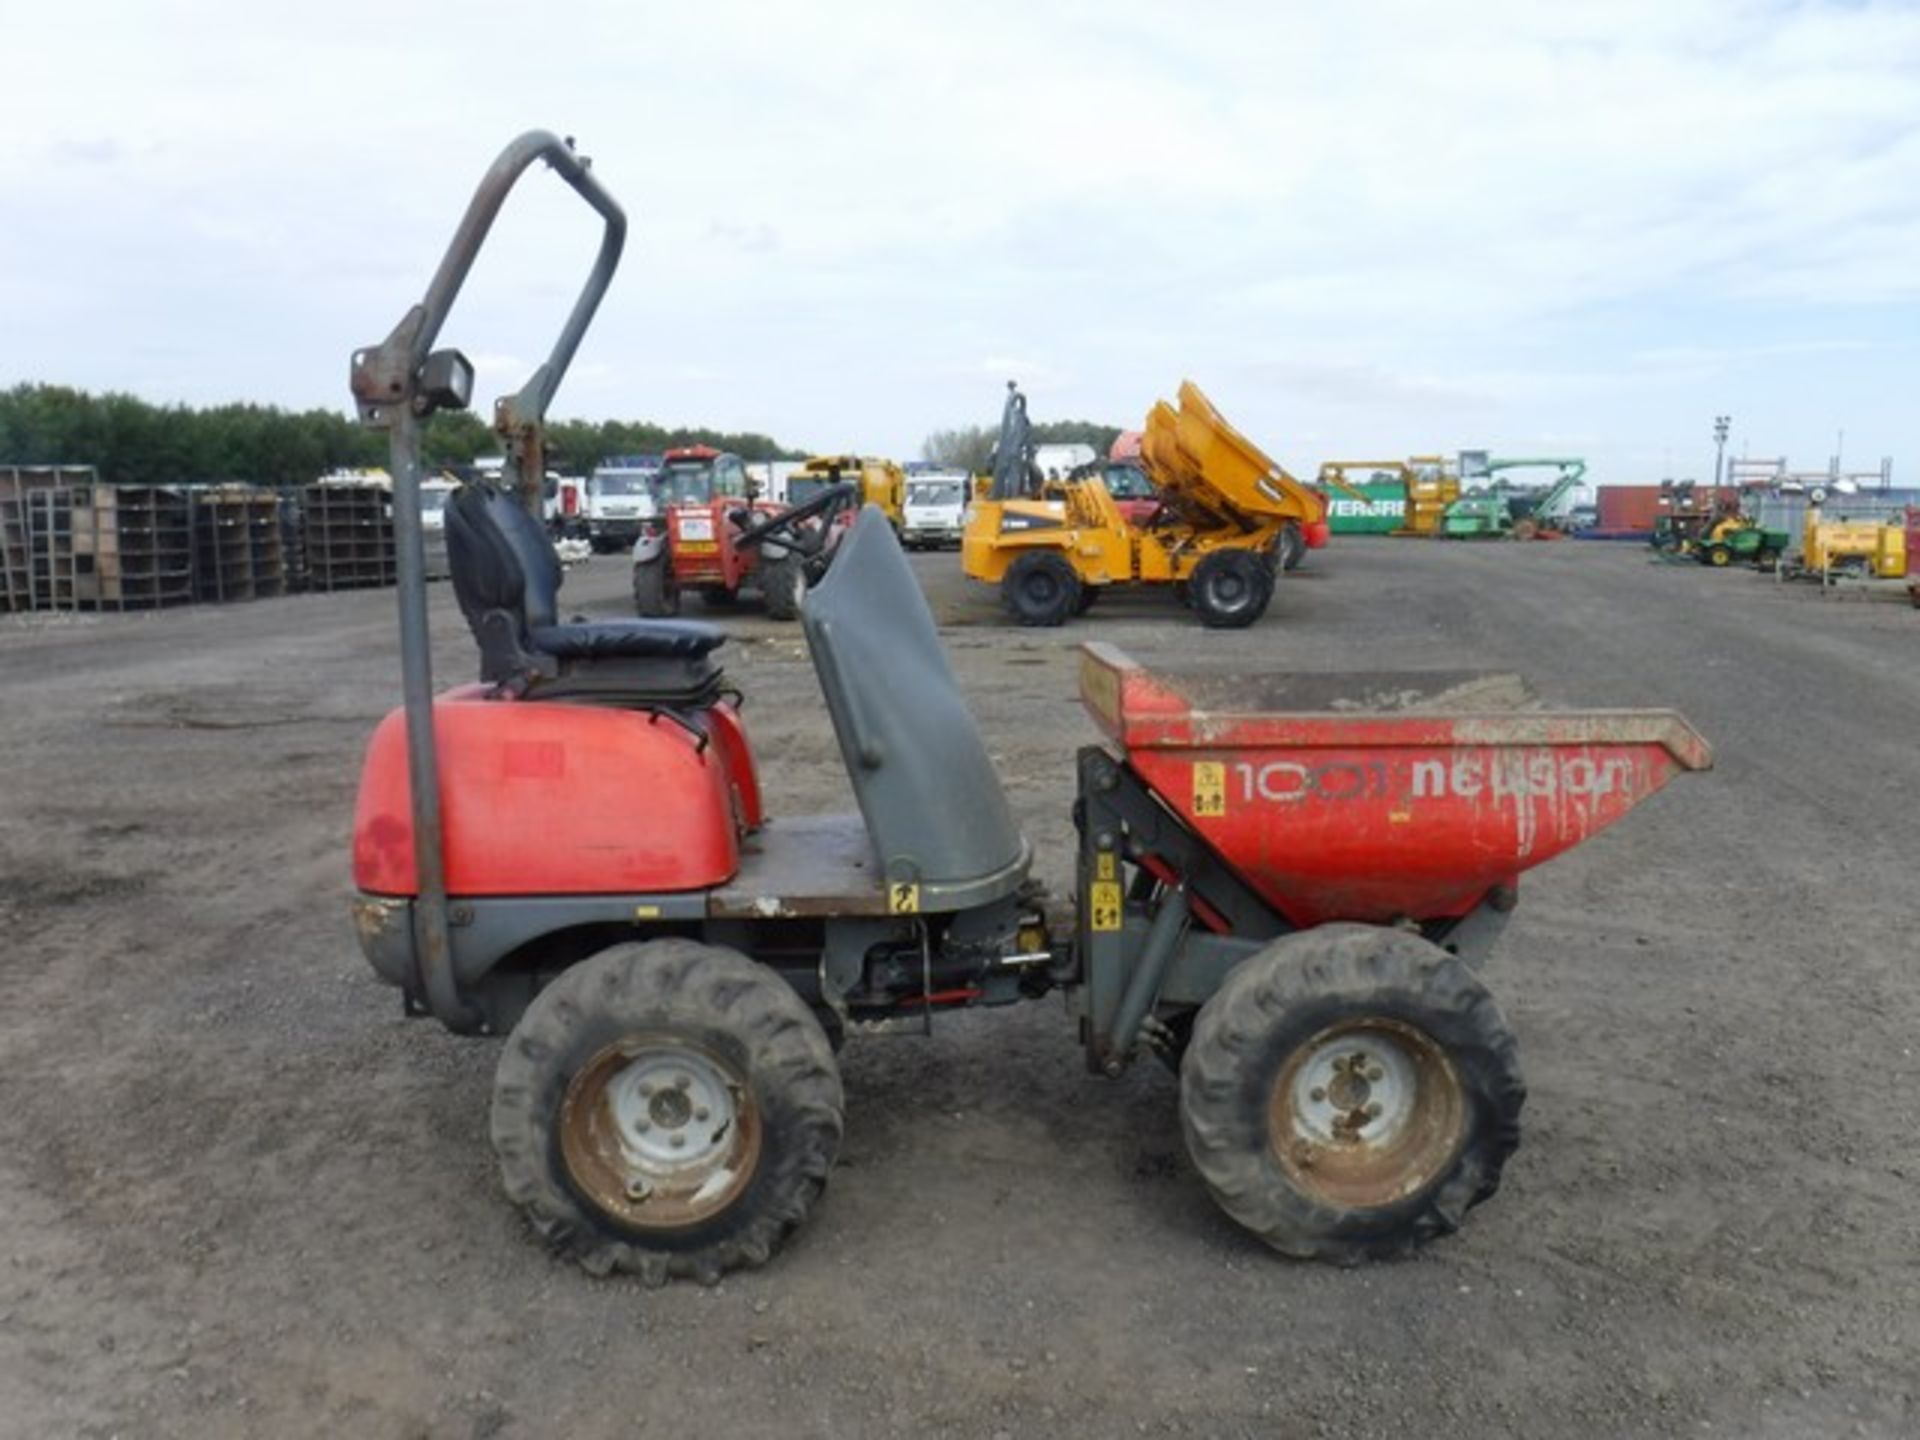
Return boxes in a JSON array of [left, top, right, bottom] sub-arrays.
[[353, 685, 744, 897]]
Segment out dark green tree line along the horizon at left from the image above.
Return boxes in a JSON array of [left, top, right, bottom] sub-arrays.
[[0, 384, 804, 486]]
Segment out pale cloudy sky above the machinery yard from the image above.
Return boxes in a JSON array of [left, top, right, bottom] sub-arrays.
[[0, 0, 1920, 484]]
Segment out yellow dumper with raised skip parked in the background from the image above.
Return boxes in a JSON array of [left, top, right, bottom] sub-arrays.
[[960, 380, 1327, 628]]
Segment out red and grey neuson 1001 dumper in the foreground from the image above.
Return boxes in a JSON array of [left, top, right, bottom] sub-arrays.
[[353, 132, 1711, 1281]]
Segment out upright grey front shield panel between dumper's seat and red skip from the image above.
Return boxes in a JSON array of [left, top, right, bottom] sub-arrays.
[[801, 505, 1027, 910]]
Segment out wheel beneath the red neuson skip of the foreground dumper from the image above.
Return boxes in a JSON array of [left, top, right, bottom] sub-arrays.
[[1181, 925, 1526, 1265]]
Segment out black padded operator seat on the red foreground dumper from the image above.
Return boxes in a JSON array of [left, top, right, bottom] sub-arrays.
[[447, 480, 726, 708]]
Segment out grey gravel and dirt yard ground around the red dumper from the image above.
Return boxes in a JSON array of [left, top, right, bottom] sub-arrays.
[[0, 541, 1920, 1436]]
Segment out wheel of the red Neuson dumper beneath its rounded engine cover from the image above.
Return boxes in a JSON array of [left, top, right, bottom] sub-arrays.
[[492, 939, 845, 1284]]
